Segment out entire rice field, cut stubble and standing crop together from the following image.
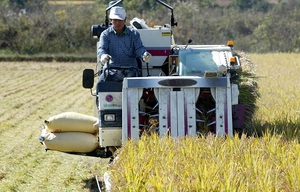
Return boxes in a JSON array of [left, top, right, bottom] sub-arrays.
[[0, 53, 300, 192]]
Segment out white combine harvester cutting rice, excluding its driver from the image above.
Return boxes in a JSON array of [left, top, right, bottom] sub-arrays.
[[41, 0, 245, 157]]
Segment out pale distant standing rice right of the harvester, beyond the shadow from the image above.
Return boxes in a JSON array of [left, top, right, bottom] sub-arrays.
[[251, 53, 300, 122]]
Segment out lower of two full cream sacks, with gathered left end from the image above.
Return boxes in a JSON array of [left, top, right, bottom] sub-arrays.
[[40, 129, 99, 153]]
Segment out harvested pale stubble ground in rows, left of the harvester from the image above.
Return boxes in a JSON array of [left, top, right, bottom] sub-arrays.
[[0, 62, 108, 191]]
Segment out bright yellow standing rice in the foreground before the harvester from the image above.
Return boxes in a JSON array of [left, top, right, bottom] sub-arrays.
[[110, 135, 300, 192]]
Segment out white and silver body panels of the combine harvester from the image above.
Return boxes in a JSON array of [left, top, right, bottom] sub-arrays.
[[97, 27, 239, 147]]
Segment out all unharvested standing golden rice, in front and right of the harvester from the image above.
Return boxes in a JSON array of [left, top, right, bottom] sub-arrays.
[[107, 53, 300, 192]]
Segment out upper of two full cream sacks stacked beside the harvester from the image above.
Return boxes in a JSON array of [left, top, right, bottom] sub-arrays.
[[45, 112, 98, 134]]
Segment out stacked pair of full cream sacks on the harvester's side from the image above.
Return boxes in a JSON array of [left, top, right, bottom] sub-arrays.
[[39, 112, 99, 153]]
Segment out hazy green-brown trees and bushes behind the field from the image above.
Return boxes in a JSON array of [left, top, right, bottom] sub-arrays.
[[0, 0, 300, 54]]
